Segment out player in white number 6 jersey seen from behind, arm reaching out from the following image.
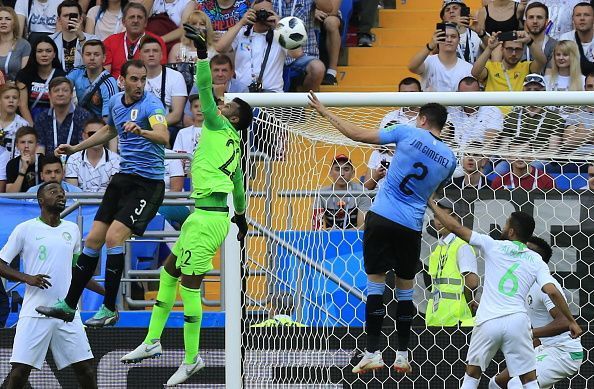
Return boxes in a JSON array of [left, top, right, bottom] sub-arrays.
[[429, 199, 582, 389]]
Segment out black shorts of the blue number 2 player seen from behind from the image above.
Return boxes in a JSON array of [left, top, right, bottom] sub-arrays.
[[363, 211, 421, 280]]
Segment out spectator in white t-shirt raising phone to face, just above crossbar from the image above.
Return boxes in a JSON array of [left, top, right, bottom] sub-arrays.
[[408, 23, 472, 92]]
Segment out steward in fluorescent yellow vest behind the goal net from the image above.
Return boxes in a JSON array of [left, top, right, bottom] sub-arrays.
[[425, 201, 479, 327]]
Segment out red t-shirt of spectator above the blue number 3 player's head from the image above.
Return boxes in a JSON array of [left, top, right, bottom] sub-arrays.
[[103, 31, 167, 78]]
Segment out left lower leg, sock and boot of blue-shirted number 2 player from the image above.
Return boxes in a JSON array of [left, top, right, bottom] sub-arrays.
[[353, 273, 386, 374]]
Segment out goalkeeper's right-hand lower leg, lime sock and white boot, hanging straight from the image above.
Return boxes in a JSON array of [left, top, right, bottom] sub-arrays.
[[167, 274, 204, 385]]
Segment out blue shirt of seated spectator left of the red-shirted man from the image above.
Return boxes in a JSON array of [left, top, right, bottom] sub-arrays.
[[66, 66, 119, 117]]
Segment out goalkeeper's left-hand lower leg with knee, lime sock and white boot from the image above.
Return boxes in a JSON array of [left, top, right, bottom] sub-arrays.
[[120, 253, 181, 363]]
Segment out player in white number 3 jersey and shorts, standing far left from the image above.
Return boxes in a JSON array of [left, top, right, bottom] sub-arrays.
[[0, 182, 97, 389]]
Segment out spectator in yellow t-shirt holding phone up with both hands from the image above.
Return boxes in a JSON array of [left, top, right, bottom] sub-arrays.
[[472, 31, 547, 92]]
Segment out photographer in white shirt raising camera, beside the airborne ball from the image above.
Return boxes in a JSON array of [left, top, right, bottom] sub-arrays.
[[215, 1, 302, 92]]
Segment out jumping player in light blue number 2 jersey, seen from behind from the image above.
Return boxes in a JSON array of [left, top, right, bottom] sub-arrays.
[[309, 92, 456, 373]]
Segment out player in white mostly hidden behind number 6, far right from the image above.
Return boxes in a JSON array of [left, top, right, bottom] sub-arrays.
[[489, 236, 584, 389]]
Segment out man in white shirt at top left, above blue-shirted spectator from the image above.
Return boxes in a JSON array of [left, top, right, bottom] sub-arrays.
[[50, 0, 97, 73]]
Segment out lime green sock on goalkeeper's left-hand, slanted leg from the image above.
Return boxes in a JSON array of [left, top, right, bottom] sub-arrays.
[[144, 267, 177, 344]]
